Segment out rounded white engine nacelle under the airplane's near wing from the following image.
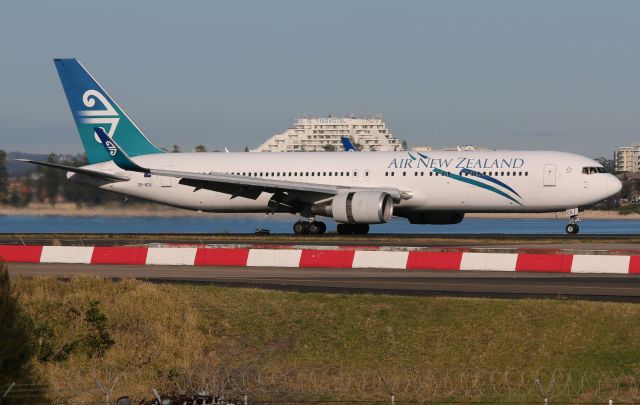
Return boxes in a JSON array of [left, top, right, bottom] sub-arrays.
[[311, 191, 393, 224]]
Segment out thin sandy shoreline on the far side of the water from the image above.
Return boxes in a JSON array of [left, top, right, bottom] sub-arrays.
[[0, 203, 640, 220]]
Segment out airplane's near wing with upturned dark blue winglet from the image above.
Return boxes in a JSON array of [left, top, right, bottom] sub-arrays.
[[95, 128, 402, 203]]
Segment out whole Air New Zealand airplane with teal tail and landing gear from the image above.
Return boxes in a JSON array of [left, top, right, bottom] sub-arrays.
[[18, 59, 622, 234]]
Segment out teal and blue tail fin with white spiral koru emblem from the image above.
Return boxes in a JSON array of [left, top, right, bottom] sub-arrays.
[[54, 59, 164, 163]]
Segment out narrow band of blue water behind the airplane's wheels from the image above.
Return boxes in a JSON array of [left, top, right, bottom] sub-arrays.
[[0, 214, 640, 235]]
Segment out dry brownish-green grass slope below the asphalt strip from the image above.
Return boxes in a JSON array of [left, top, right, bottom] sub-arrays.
[[14, 278, 640, 400]]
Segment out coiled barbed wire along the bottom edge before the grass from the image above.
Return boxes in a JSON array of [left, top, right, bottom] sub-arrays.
[[146, 367, 640, 402]]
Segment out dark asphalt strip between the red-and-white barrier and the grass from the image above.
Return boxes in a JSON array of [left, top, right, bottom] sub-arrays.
[[9, 263, 640, 302]]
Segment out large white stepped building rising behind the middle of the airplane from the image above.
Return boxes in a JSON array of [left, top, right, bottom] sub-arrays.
[[251, 117, 402, 152]]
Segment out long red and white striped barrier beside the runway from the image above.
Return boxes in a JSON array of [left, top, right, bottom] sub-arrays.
[[0, 245, 640, 275]]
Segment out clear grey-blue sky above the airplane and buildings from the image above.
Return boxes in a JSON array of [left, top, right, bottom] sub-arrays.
[[0, 0, 640, 156]]
